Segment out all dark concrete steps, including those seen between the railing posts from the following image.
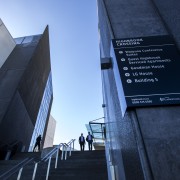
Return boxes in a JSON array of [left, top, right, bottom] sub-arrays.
[[0, 150, 108, 180]]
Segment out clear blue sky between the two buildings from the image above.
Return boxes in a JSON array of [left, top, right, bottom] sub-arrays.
[[0, 0, 103, 149]]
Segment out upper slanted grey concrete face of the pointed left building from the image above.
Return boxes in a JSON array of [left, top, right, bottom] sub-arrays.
[[0, 41, 35, 126]]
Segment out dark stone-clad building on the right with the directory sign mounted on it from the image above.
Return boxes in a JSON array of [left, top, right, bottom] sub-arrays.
[[97, 0, 180, 180]]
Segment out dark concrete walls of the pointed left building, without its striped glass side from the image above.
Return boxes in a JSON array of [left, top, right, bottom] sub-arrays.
[[0, 22, 52, 150]]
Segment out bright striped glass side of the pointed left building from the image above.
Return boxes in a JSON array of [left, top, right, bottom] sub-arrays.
[[29, 73, 53, 151]]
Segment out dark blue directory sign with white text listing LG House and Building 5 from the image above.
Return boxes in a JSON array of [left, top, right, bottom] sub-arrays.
[[111, 36, 180, 113]]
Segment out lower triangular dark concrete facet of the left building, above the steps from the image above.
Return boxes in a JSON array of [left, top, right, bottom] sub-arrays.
[[0, 92, 34, 150]]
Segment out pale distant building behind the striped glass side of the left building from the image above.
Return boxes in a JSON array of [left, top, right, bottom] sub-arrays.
[[43, 115, 56, 148]]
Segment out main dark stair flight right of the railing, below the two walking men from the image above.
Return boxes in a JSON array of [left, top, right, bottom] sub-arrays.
[[47, 151, 108, 180]]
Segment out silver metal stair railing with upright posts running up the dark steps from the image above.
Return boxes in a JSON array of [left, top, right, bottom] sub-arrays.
[[0, 139, 75, 180]]
